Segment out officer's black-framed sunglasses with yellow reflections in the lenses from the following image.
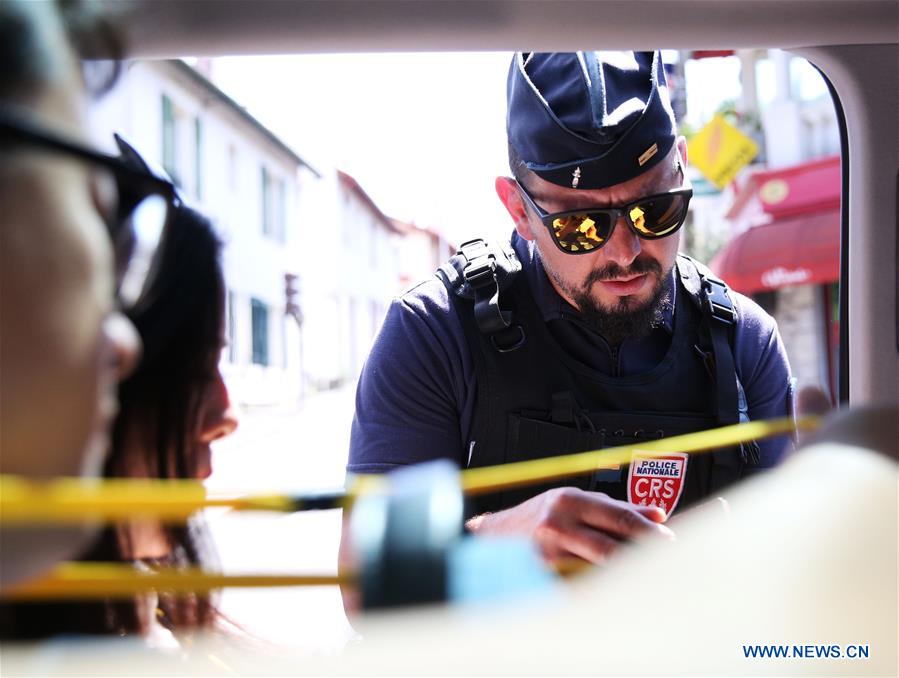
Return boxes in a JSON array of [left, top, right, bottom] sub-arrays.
[[515, 180, 693, 254]]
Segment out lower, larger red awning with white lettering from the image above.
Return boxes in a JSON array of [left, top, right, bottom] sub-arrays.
[[710, 210, 840, 294]]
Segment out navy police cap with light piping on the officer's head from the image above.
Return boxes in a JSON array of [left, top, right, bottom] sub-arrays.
[[506, 51, 675, 189]]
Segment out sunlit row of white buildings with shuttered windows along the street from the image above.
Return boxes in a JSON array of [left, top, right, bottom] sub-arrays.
[[91, 61, 408, 406]]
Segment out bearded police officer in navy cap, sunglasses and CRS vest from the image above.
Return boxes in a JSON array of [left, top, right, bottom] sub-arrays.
[[348, 52, 790, 562]]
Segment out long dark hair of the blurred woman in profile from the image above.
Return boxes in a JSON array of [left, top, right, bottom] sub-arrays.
[[105, 206, 225, 628]]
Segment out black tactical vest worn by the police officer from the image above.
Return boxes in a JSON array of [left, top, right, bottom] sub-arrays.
[[438, 240, 758, 515]]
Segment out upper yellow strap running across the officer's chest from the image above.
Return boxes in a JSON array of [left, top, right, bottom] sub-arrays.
[[0, 417, 819, 524]]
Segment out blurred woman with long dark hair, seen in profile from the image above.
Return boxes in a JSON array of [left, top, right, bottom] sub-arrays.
[[99, 189, 237, 633]]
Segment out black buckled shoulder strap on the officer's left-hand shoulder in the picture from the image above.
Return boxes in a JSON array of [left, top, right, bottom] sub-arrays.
[[437, 238, 524, 351]]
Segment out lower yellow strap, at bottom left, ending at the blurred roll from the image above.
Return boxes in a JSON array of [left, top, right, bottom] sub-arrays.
[[0, 563, 354, 600]]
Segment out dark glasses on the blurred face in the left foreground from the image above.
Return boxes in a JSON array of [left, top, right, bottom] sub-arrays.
[[0, 107, 176, 309]]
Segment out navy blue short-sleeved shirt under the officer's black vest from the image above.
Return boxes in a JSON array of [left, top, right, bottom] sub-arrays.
[[347, 234, 790, 473]]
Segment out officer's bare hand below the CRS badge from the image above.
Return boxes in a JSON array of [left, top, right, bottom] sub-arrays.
[[466, 487, 674, 564]]
